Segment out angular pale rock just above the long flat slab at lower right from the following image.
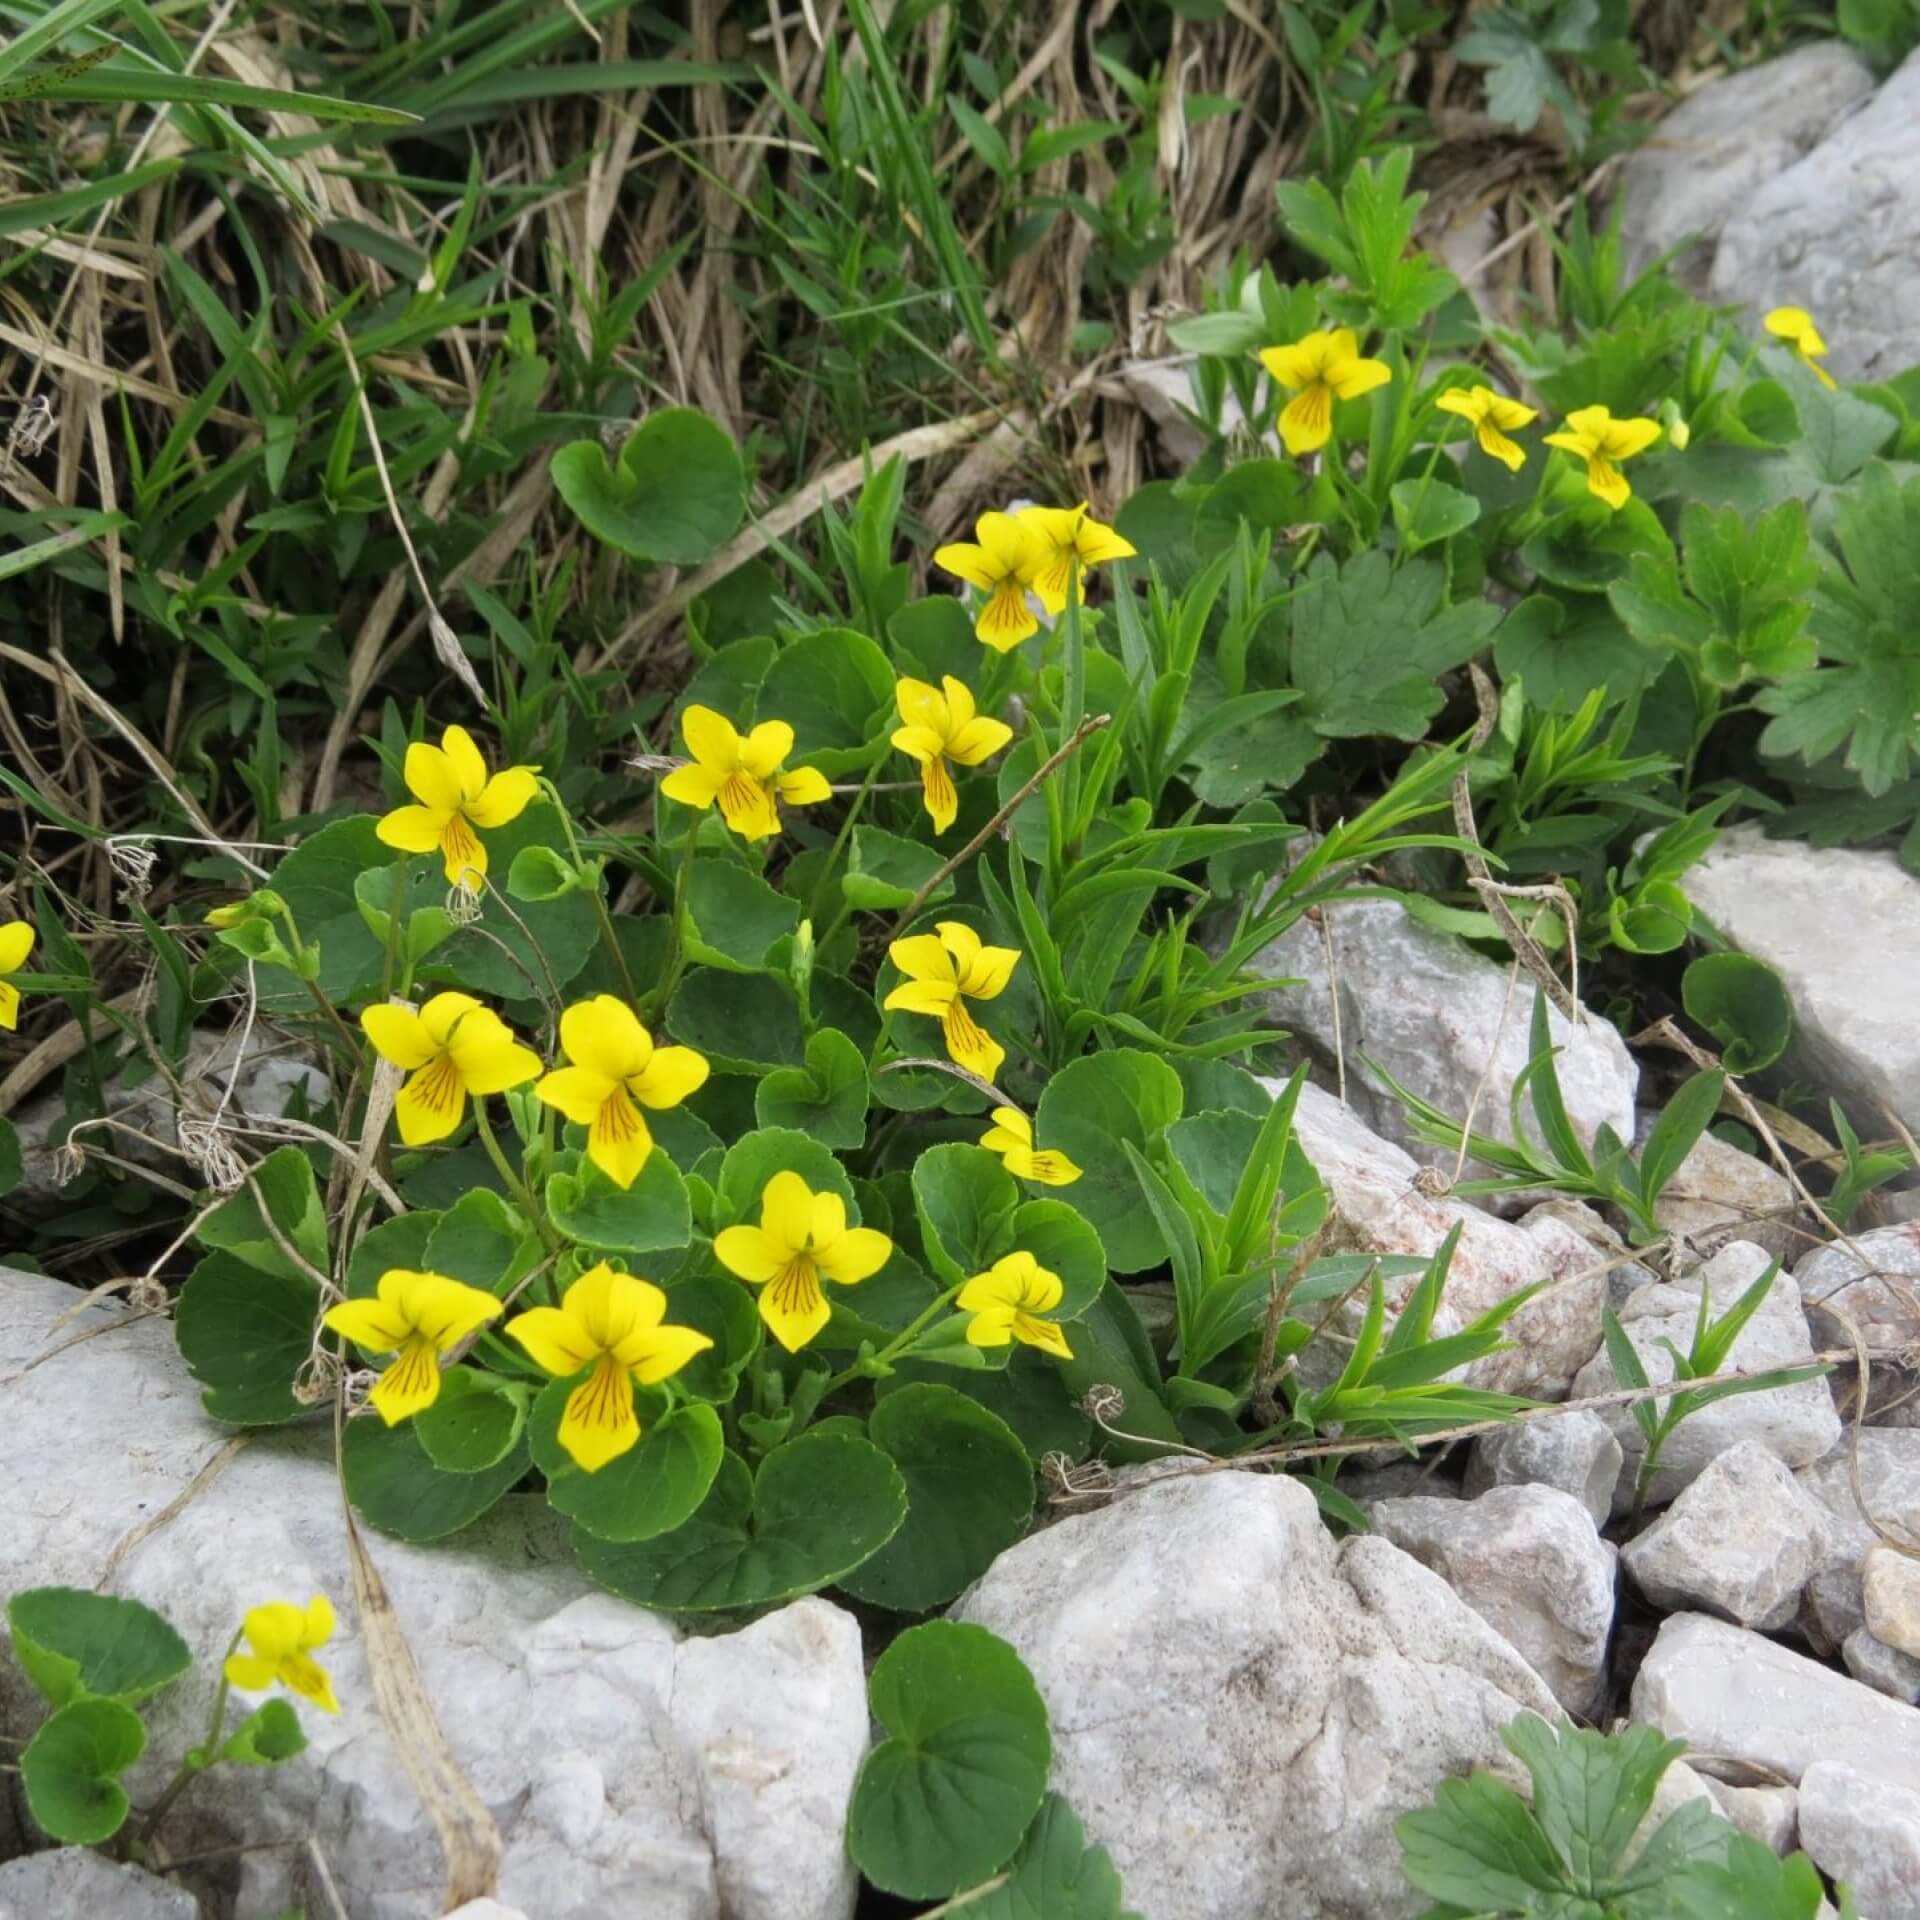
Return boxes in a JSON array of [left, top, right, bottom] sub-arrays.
[[1620, 1440, 1828, 1630]]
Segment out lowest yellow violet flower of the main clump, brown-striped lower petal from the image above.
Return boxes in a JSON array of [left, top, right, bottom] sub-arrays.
[[507, 1260, 712, 1473]]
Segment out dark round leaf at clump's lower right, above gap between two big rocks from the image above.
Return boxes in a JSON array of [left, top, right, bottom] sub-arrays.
[[841, 1384, 1033, 1613]]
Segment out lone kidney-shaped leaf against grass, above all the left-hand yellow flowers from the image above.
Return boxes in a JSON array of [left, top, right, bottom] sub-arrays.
[[553, 407, 747, 566]]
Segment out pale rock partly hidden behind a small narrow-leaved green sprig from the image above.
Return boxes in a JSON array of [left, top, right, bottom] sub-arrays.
[[1572, 1240, 1839, 1511]]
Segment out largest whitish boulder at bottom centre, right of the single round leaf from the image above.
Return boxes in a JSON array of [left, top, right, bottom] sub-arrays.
[[954, 1473, 1557, 1920]]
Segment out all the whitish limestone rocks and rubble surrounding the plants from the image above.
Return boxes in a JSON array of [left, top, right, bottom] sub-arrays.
[[11, 46, 1920, 1920]]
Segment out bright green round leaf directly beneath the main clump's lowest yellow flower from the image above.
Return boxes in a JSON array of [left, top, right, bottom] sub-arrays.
[[532, 1375, 726, 1542]]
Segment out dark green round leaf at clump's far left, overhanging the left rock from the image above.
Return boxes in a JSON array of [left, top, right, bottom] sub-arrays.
[[173, 1254, 321, 1427]]
